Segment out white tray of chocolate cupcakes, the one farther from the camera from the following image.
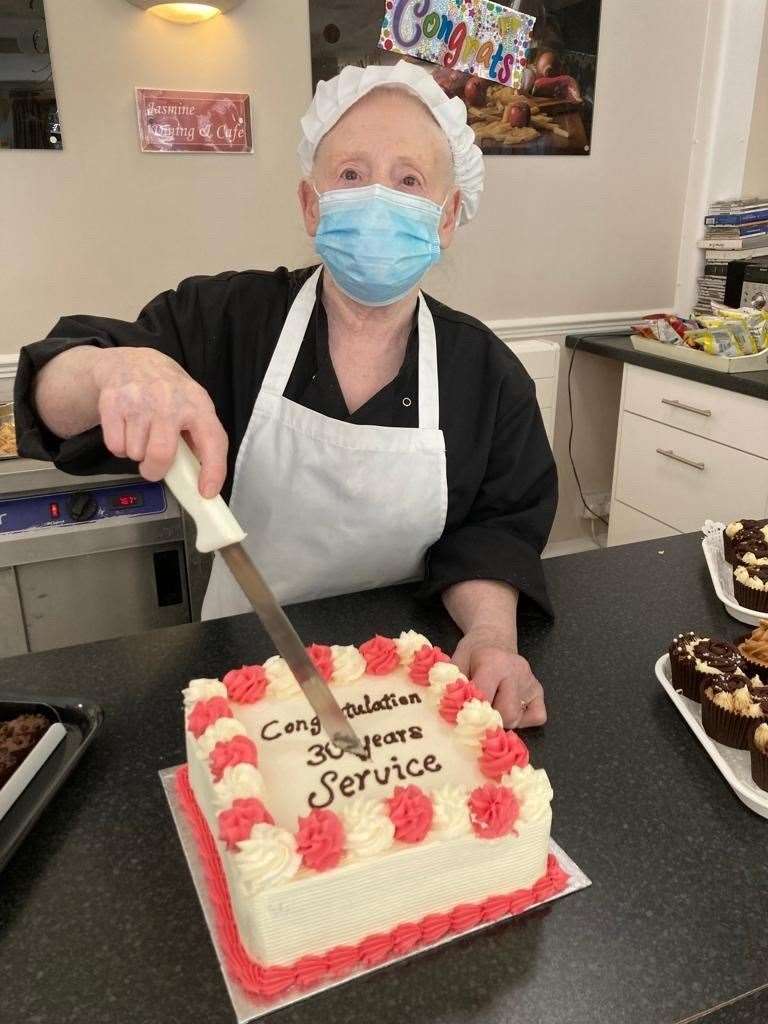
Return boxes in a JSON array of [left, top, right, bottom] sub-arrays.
[[701, 519, 768, 626]]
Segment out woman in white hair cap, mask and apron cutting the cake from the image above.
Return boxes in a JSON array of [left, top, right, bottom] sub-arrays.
[[16, 62, 556, 726]]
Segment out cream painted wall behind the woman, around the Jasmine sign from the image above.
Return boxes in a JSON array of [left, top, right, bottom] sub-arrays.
[[0, 0, 706, 538]]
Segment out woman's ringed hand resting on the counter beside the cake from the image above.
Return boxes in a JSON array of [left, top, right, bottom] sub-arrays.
[[453, 632, 547, 729]]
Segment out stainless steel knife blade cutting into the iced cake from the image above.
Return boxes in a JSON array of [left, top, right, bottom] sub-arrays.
[[219, 544, 367, 758]]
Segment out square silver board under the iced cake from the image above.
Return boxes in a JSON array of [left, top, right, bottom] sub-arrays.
[[159, 765, 592, 1024]]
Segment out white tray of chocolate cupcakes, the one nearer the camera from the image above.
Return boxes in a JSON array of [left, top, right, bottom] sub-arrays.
[[655, 620, 768, 818]]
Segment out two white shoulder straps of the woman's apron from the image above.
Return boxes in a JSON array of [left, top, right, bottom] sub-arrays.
[[261, 265, 440, 430]]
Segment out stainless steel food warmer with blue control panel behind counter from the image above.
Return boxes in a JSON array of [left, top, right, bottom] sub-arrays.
[[0, 459, 204, 656]]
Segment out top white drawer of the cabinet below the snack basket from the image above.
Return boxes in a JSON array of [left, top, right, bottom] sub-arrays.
[[624, 366, 768, 459]]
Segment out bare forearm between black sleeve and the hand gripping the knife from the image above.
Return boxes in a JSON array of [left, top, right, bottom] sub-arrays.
[[34, 345, 104, 438]]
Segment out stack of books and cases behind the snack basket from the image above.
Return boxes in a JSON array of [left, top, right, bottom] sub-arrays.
[[692, 198, 768, 316]]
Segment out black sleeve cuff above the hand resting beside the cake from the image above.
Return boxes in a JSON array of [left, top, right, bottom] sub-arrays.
[[420, 523, 554, 618]]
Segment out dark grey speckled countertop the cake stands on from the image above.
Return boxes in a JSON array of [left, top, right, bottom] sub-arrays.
[[0, 535, 768, 1024]]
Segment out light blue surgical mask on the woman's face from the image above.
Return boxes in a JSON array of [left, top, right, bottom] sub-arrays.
[[314, 184, 444, 306]]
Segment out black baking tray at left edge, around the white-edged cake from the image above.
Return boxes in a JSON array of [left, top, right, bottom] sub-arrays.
[[0, 696, 104, 870]]
